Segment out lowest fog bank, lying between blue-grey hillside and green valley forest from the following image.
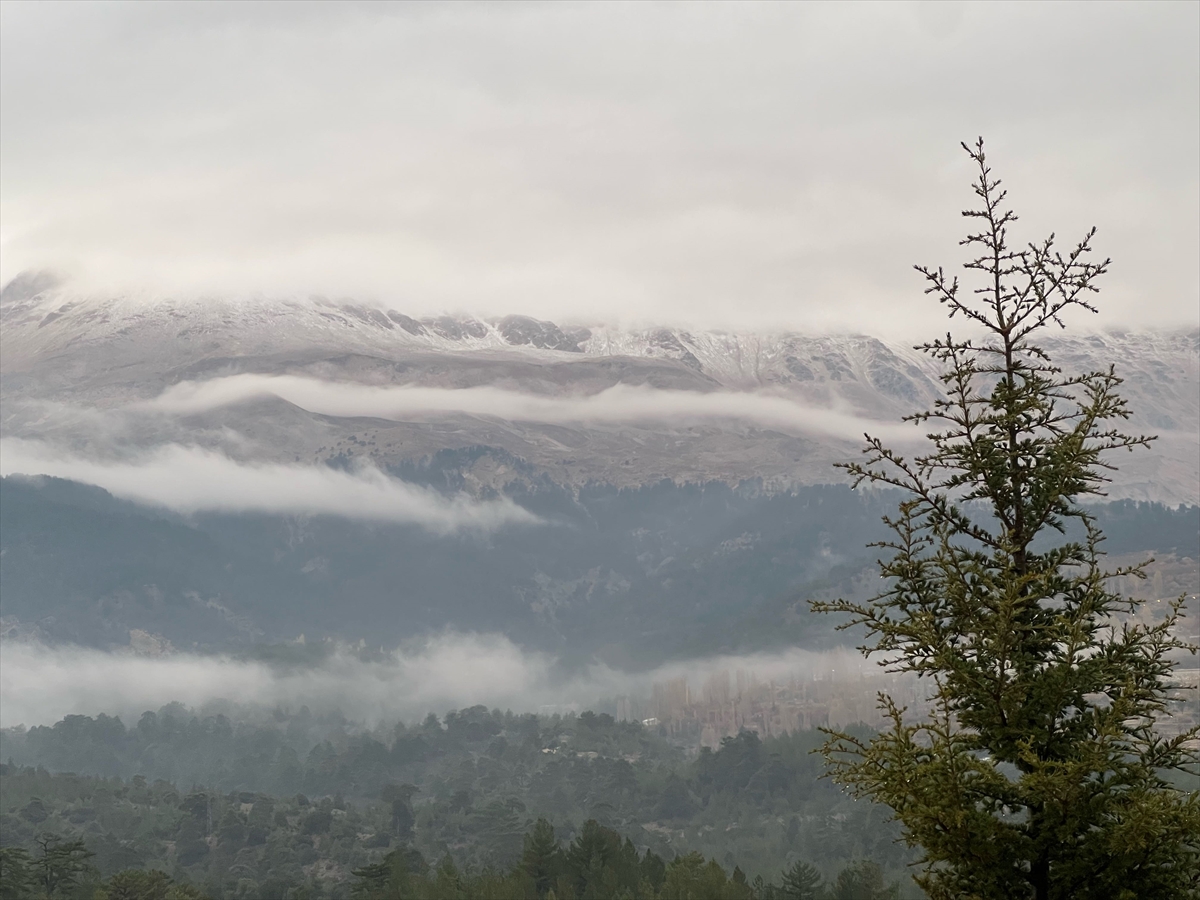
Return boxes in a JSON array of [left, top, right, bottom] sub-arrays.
[[0, 634, 880, 727]]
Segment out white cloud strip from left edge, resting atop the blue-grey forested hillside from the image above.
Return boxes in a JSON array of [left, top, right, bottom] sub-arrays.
[[0, 438, 539, 534]]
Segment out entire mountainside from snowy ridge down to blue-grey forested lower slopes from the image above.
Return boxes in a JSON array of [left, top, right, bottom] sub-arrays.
[[0, 271, 1200, 667]]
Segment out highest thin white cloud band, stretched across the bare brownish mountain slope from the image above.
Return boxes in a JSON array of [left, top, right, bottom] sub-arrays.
[[138, 374, 916, 440]]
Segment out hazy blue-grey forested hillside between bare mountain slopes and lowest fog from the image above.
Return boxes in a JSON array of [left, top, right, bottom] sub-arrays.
[[0, 475, 1200, 668]]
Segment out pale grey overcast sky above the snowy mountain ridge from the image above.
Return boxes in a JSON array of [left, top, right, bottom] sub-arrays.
[[0, 0, 1200, 332]]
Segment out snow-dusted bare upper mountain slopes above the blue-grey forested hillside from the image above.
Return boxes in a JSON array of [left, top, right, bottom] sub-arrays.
[[0, 275, 1200, 503]]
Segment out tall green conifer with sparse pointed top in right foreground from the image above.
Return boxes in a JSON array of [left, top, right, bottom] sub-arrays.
[[814, 139, 1200, 900]]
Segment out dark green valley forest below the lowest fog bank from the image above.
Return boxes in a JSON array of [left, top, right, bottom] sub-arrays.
[[0, 704, 910, 900]]
